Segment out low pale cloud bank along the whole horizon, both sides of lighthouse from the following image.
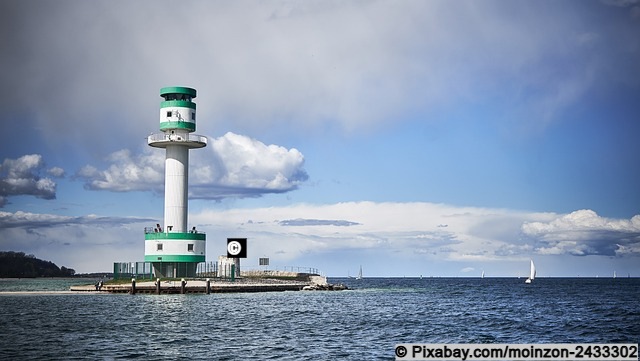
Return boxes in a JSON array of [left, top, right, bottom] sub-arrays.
[[0, 202, 640, 275]]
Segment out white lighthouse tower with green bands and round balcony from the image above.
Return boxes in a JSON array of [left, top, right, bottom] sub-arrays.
[[144, 87, 207, 277]]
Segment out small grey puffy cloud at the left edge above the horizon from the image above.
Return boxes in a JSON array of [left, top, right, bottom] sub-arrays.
[[0, 154, 64, 207]]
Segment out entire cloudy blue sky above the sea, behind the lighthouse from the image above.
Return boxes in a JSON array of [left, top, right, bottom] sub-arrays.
[[0, 0, 640, 277]]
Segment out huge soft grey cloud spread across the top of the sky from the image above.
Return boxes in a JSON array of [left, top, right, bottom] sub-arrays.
[[0, 0, 638, 151]]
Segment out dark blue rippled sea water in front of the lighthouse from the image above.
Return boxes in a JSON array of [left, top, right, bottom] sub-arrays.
[[0, 278, 640, 360]]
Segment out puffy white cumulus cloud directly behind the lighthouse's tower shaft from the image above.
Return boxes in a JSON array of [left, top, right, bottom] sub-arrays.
[[77, 133, 309, 200]]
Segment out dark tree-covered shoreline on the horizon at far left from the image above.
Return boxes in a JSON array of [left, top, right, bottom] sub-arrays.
[[0, 251, 76, 278]]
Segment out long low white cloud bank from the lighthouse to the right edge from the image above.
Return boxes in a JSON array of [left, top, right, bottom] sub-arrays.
[[191, 202, 640, 269]]
